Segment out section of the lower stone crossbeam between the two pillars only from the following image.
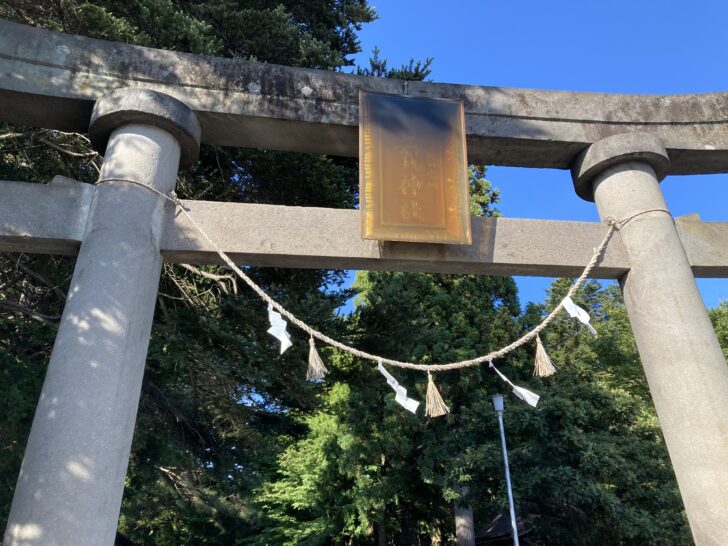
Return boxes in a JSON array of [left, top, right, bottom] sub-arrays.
[[163, 201, 629, 278]]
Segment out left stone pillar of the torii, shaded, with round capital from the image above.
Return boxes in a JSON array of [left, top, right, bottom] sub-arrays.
[[4, 89, 200, 546]]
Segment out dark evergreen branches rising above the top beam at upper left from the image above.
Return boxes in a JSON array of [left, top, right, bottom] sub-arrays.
[[0, 0, 374, 69]]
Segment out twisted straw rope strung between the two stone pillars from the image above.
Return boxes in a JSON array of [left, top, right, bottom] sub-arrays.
[[96, 178, 670, 372]]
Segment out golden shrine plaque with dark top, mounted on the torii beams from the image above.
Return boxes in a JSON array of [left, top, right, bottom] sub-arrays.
[[359, 91, 472, 244]]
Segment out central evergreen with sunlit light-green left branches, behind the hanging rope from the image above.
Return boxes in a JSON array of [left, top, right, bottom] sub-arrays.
[[253, 168, 520, 544]]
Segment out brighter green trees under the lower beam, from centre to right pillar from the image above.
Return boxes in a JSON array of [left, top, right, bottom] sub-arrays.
[[259, 273, 690, 544]]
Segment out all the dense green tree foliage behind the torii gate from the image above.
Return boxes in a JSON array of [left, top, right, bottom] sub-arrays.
[[0, 0, 728, 546]]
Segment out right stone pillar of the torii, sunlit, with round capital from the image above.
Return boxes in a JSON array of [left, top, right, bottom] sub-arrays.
[[572, 133, 728, 546]]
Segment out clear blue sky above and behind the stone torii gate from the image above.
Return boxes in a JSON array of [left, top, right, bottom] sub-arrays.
[[346, 0, 728, 307]]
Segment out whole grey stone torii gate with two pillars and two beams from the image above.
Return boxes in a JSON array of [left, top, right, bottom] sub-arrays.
[[0, 18, 728, 546]]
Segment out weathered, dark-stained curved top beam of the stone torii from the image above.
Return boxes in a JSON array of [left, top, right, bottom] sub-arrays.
[[0, 21, 728, 174]]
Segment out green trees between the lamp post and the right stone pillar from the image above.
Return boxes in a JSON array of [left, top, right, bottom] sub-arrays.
[[501, 279, 690, 545]]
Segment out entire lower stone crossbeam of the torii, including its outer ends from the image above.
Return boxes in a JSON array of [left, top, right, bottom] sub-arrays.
[[0, 177, 728, 278]]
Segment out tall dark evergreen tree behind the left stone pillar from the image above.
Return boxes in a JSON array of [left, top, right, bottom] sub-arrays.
[[0, 0, 375, 545]]
